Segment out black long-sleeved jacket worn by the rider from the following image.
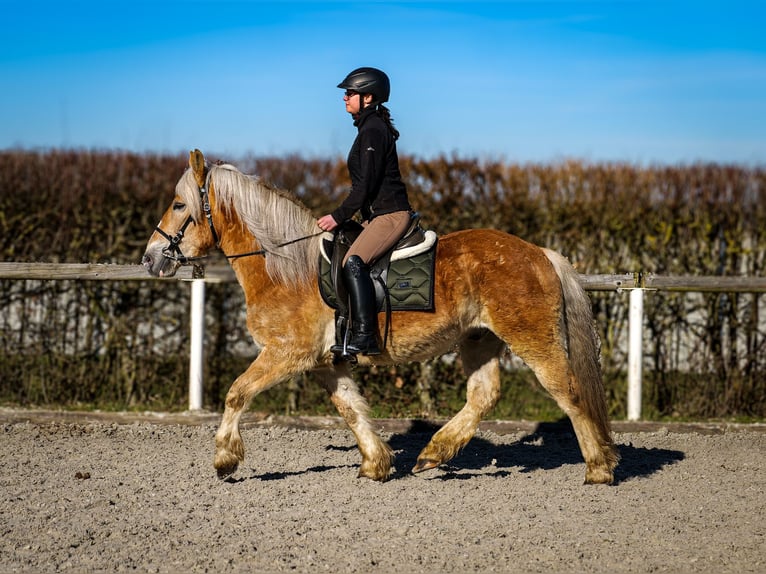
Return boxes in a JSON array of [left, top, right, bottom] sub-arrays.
[[331, 108, 411, 223]]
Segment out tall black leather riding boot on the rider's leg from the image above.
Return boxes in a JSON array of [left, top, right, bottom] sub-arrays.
[[343, 255, 380, 355]]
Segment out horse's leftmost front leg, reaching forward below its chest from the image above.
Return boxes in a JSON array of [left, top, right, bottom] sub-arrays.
[[213, 347, 308, 479]]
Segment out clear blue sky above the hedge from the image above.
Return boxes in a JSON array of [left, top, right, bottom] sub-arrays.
[[0, 0, 766, 166]]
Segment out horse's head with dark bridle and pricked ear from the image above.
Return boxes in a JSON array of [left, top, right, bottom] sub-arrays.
[[141, 149, 218, 277]]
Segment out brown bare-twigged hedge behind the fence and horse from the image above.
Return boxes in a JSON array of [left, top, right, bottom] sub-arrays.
[[0, 151, 766, 418]]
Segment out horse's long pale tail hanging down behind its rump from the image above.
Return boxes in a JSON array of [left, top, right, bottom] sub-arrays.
[[543, 249, 612, 438]]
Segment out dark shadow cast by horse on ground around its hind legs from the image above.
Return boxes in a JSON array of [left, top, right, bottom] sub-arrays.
[[388, 419, 684, 484]]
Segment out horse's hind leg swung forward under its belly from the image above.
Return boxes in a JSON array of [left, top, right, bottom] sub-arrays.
[[412, 330, 505, 472]]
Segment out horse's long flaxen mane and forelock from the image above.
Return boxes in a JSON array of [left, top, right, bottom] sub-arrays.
[[178, 164, 321, 285]]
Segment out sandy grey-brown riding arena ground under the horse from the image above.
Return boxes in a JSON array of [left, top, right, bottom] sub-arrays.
[[0, 411, 766, 573]]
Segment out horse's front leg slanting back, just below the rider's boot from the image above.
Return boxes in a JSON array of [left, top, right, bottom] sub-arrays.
[[315, 363, 394, 481]]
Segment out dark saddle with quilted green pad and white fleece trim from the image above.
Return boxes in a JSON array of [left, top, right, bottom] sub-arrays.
[[319, 213, 437, 323]]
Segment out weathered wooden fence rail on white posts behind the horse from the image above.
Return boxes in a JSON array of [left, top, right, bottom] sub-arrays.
[[0, 262, 766, 421]]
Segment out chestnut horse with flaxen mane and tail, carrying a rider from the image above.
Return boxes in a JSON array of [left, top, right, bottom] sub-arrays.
[[143, 150, 618, 484]]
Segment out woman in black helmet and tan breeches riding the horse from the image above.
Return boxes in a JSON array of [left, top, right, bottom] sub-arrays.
[[317, 68, 411, 355]]
